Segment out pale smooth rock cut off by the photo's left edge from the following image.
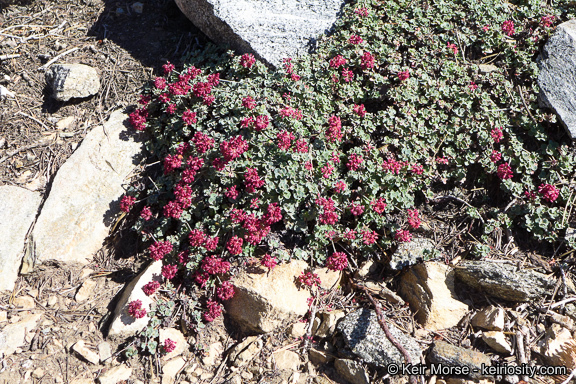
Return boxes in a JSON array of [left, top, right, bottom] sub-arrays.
[[0, 185, 42, 291]]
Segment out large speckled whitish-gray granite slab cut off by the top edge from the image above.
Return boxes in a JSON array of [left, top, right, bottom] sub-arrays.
[[176, 0, 345, 67]]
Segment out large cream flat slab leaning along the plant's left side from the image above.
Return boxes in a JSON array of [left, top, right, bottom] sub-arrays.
[[22, 111, 141, 273]]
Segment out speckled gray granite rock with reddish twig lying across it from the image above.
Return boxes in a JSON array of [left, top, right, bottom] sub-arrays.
[[336, 308, 422, 367]]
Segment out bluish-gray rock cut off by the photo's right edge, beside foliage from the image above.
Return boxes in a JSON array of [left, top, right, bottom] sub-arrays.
[[538, 20, 576, 139]]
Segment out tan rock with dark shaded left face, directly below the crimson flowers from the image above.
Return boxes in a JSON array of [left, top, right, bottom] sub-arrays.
[[224, 260, 310, 333]]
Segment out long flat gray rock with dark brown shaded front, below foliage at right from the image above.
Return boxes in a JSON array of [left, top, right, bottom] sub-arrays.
[[454, 261, 555, 302]]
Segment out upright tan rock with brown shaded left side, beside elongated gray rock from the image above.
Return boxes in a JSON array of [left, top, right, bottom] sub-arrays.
[[400, 262, 468, 331]]
